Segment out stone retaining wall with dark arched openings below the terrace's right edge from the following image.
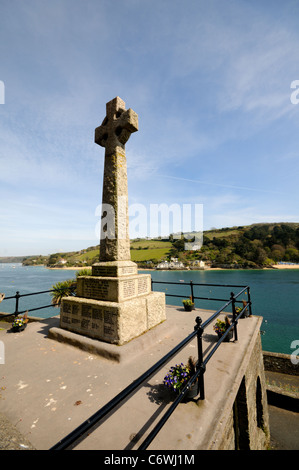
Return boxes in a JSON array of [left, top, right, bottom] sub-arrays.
[[206, 324, 270, 450]]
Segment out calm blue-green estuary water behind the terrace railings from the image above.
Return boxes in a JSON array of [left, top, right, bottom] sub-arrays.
[[0, 263, 299, 354]]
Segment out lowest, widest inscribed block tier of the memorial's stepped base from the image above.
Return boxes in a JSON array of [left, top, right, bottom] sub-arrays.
[[60, 292, 166, 345]]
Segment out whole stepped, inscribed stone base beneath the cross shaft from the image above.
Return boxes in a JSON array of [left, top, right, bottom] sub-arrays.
[[60, 260, 166, 345]]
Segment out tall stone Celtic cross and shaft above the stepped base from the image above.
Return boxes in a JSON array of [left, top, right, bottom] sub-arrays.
[[95, 97, 138, 261]]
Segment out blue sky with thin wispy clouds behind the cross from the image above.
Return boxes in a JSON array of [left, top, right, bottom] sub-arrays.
[[0, 0, 299, 256]]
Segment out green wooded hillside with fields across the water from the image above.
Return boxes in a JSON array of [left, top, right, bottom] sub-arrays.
[[23, 223, 299, 268]]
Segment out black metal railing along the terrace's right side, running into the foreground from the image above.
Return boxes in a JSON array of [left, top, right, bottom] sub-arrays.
[[50, 281, 252, 450]]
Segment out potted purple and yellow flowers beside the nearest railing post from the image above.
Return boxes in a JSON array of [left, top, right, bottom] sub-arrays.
[[163, 356, 197, 400]]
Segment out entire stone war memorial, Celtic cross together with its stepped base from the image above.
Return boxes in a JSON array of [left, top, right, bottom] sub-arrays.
[[60, 97, 166, 345]]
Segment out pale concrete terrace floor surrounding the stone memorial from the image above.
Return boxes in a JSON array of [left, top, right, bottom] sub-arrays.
[[0, 306, 261, 450]]
